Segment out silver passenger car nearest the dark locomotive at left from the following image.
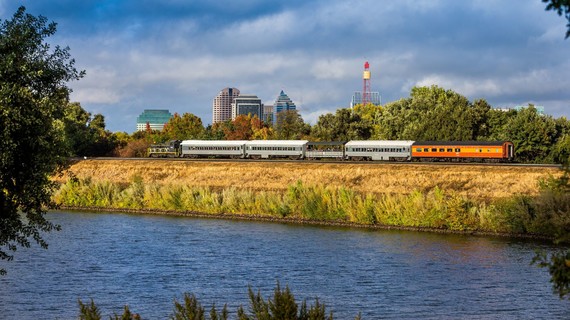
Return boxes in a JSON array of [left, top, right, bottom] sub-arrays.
[[180, 140, 247, 159]]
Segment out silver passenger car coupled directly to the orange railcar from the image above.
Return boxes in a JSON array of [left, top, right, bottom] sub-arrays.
[[345, 140, 414, 161]]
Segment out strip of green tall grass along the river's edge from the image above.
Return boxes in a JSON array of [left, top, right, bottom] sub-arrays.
[[54, 176, 570, 236]]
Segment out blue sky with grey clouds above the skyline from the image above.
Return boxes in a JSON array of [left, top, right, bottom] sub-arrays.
[[0, 0, 570, 133]]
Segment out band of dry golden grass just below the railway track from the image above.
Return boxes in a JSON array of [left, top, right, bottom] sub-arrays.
[[56, 159, 562, 200]]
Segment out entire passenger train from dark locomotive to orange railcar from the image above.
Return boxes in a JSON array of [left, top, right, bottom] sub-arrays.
[[147, 140, 515, 162]]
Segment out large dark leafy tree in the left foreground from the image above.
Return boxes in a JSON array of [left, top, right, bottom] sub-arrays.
[[0, 6, 85, 273]]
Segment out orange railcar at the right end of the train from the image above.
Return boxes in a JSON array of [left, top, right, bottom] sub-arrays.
[[412, 141, 515, 162]]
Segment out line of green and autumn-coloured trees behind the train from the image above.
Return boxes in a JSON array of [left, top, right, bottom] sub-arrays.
[[67, 86, 570, 163]]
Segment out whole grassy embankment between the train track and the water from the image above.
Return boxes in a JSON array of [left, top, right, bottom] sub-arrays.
[[54, 159, 570, 237]]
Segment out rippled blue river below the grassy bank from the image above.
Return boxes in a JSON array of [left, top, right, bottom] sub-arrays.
[[0, 212, 570, 319]]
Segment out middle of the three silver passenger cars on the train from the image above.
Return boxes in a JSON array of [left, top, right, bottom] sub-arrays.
[[245, 140, 309, 159]]
